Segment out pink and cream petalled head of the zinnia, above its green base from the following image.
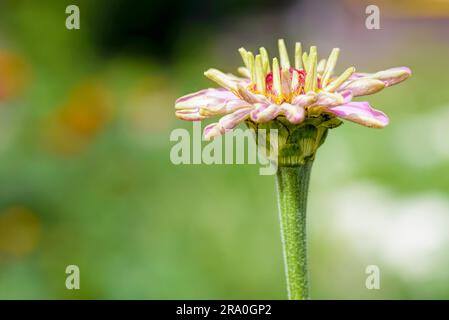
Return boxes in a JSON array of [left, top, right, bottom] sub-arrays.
[[175, 39, 411, 139]]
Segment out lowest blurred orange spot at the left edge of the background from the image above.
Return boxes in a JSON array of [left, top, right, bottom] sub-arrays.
[[0, 206, 41, 257]]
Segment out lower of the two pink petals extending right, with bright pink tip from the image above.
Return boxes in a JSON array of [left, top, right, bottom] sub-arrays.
[[327, 102, 389, 128]]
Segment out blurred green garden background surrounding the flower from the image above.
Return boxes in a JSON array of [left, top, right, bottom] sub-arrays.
[[0, 0, 449, 299]]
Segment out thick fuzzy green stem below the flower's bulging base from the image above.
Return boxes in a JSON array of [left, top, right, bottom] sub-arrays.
[[276, 160, 313, 300]]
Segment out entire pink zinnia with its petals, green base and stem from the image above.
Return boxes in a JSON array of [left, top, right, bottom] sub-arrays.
[[176, 39, 411, 299]]
